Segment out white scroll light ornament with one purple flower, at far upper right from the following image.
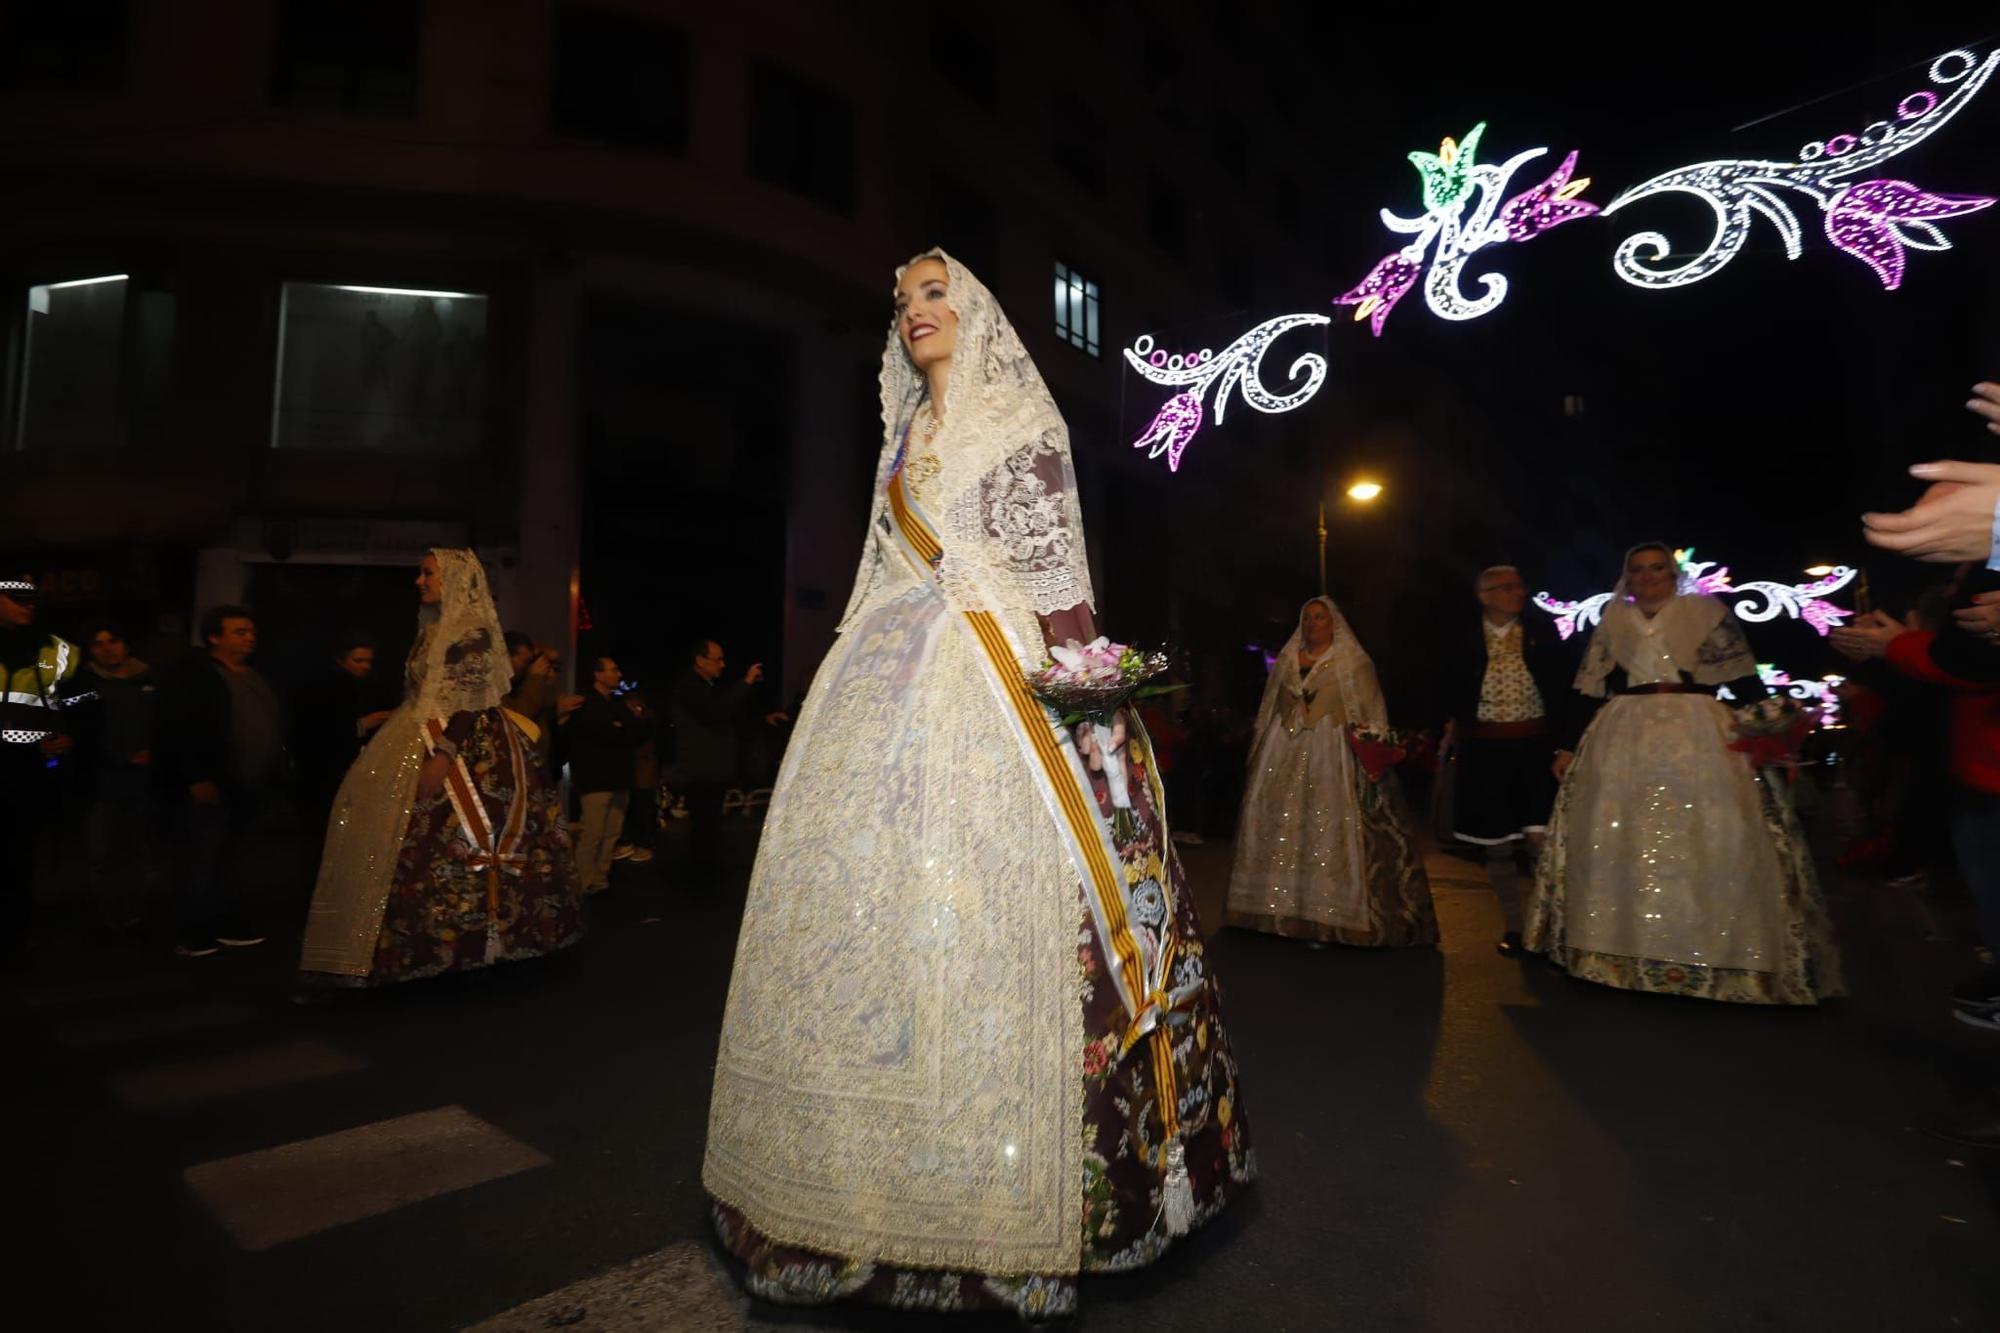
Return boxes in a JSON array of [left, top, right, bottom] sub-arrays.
[[1604, 48, 2000, 292]]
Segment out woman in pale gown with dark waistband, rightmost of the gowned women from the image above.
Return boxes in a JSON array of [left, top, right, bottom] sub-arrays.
[[1528, 542, 1840, 1005]]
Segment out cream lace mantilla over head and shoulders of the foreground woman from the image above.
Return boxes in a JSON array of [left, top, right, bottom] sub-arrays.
[[840, 250, 1096, 664]]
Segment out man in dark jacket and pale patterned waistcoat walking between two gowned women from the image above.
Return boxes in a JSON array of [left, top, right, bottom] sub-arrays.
[[1444, 564, 1570, 957]]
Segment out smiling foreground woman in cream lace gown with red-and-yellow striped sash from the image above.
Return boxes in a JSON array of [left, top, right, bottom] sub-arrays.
[[702, 250, 1252, 1315]]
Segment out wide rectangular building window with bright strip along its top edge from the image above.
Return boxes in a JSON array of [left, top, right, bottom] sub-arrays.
[[270, 282, 488, 454]]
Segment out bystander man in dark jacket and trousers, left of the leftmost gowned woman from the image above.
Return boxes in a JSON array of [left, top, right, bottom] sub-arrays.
[[154, 606, 286, 959]]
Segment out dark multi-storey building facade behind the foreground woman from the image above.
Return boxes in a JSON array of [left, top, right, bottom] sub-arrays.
[[0, 0, 1330, 695]]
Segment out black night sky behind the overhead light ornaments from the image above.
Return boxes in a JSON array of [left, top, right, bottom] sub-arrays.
[[1126, 6, 2000, 703]]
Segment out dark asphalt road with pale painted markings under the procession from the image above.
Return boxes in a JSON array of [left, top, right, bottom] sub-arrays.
[[15, 820, 2000, 1333]]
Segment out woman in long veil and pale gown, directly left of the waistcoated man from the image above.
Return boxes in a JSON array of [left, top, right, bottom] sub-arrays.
[[1224, 596, 1438, 947]]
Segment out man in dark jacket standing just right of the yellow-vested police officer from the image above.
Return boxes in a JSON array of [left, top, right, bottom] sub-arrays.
[[84, 624, 160, 931]]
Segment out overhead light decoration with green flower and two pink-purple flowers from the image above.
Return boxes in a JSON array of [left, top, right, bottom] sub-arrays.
[[1334, 120, 1598, 338]]
